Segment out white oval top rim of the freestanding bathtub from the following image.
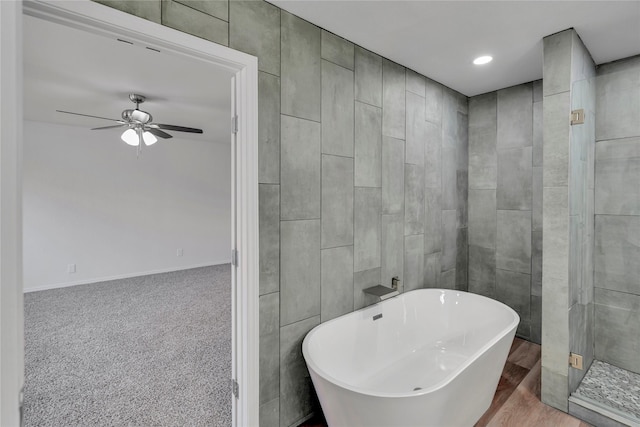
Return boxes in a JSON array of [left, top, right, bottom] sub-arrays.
[[302, 288, 520, 398]]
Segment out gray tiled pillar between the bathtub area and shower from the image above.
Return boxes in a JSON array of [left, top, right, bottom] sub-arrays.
[[544, 29, 595, 412]]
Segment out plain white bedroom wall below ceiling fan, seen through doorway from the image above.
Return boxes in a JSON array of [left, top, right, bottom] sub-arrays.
[[23, 121, 231, 291]]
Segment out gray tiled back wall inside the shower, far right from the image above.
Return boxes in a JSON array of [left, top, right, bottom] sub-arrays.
[[594, 57, 640, 373]]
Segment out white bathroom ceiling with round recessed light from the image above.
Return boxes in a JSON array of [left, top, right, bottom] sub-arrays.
[[269, 0, 640, 96]]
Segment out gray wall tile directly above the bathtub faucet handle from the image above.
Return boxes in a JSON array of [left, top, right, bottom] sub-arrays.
[[380, 214, 404, 286]]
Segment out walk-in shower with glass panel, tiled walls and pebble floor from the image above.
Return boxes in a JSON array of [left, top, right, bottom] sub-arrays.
[[568, 57, 640, 426]]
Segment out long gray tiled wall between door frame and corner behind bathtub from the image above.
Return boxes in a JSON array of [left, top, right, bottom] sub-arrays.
[[90, 0, 468, 426]]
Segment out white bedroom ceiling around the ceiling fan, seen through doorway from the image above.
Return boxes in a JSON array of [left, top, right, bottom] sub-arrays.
[[23, 14, 231, 143]]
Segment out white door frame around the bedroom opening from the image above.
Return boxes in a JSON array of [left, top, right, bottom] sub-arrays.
[[0, 0, 259, 426]]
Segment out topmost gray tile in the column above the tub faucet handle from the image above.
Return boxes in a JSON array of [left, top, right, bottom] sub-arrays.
[[382, 58, 406, 139]]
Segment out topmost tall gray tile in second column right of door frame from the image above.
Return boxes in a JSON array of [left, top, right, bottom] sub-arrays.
[[280, 10, 321, 122]]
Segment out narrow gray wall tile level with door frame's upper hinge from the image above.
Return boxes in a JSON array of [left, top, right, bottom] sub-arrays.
[[258, 71, 280, 184]]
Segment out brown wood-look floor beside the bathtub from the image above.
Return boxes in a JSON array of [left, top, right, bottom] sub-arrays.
[[300, 338, 589, 427]]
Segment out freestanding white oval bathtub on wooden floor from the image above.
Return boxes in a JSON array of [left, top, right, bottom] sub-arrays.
[[302, 289, 520, 427]]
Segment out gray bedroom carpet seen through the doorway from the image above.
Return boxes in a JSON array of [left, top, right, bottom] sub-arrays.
[[24, 264, 231, 427]]
